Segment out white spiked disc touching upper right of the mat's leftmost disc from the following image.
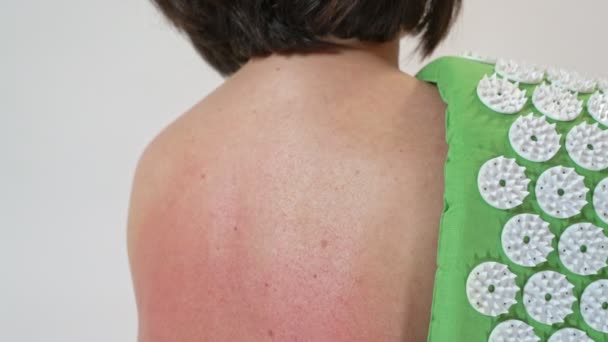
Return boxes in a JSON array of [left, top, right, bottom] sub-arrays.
[[501, 214, 555, 267]]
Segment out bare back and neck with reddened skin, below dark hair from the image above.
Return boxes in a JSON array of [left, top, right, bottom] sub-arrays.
[[128, 40, 447, 342]]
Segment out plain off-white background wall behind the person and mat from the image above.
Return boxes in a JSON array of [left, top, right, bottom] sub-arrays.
[[0, 0, 608, 342]]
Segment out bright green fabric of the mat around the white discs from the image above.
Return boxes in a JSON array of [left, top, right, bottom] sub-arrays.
[[416, 56, 608, 342]]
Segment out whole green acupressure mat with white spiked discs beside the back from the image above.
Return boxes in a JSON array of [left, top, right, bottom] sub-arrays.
[[416, 53, 608, 342]]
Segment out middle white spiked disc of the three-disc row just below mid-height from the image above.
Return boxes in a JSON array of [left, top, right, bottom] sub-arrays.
[[535, 166, 589, 218]]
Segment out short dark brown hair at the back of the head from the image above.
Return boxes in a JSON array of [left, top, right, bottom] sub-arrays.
[[152, 0, 462, 76]]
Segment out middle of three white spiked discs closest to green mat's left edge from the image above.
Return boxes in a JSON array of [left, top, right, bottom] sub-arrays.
[[477, 156, 530, 209]]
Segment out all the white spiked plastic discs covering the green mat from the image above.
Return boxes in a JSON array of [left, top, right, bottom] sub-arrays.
[[460, 55, 608, 342]]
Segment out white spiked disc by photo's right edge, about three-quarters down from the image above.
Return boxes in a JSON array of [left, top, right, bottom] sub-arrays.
[[557, 222, 608, 275]]
